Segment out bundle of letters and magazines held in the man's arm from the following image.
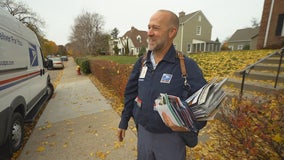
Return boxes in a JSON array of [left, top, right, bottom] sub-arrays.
[[154, 78, 227, 130]]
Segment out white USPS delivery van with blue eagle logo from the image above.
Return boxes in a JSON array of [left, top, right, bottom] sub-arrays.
[[0, 7, 53, 155]]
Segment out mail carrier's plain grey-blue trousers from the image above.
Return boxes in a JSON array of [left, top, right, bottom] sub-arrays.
[[138, 125, 186, 160]]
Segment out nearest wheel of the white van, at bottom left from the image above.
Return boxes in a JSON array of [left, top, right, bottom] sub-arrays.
[[5, 113, 24, 155]]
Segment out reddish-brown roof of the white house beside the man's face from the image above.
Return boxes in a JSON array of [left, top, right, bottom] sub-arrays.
[[122, 27, 148, 48]]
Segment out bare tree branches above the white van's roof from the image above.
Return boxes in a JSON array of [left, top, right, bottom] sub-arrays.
[[0, 0, 45, 36]]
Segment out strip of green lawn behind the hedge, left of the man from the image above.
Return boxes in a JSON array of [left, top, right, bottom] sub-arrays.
[[92, 56, 138, 64]]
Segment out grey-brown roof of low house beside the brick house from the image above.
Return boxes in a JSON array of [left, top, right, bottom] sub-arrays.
[[228, 27, 259, 42]]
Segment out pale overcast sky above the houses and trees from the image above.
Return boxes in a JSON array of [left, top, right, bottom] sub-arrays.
[[22, 0, 264, 45]]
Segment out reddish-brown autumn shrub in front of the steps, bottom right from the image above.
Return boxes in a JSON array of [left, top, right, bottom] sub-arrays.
[[204, 91, 284, 160]]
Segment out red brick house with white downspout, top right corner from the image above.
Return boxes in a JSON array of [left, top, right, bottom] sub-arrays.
[[257, 0, 284, 49]]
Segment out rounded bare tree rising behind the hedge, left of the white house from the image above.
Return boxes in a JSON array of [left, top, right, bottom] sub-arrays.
[[69, 12, 105, 55]]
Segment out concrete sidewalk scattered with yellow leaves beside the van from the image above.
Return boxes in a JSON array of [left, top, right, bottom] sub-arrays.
[[17, 58, 137, 160]]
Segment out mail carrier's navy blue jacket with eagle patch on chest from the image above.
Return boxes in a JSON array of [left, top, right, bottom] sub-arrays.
[[119, 45, 207, 133]]
